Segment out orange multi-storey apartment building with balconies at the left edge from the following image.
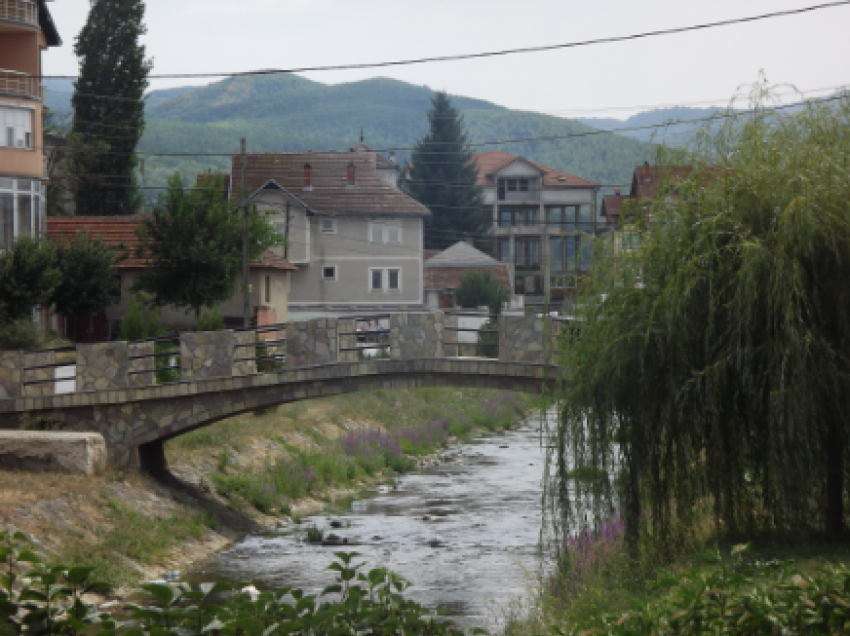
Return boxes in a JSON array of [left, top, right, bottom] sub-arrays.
[[0, 0, 61, 250]]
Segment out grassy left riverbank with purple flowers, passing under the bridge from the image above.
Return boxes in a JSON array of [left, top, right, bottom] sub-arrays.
[[0, 389, 535, 593]]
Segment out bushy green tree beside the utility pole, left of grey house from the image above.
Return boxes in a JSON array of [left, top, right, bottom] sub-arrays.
[[134, 174, 283, 319]]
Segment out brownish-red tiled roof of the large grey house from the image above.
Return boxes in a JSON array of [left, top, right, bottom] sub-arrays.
[[231, 151, 431, 217]]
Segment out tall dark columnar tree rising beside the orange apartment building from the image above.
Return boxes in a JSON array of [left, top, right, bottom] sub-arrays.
[[72, 0, 152, 215]]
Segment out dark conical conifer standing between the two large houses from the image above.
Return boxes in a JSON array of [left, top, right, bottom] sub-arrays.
[[404, 93, 484, 249]]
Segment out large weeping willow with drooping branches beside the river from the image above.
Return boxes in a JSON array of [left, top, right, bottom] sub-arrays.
[[546, 86, 850, 549]]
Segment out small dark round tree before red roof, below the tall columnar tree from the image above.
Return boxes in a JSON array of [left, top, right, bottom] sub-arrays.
[[51, 232, 120, 336]]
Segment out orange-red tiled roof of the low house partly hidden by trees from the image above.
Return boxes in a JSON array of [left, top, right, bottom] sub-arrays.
[[47, 216, 298, 271]]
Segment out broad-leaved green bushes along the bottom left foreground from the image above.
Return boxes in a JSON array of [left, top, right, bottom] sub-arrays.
[[0, 532, 470, 636]]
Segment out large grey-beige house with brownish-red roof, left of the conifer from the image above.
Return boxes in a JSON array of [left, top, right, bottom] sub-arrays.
[[229, 142, 430, 317]]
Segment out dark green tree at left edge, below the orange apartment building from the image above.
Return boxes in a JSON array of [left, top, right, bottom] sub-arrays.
[[0, 237, 62, 320]]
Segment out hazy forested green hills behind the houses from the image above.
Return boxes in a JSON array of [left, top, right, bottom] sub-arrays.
[[48, 75, 651, 190]]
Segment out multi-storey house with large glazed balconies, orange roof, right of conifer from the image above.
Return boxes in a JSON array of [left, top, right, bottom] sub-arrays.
[[474, 151, 605, 306]]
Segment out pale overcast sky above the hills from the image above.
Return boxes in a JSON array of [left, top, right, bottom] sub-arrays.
[[44, 0, 850, 118]]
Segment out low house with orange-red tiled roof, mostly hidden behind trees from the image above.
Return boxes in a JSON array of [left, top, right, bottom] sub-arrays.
[[47, 216, 297, 341]]
